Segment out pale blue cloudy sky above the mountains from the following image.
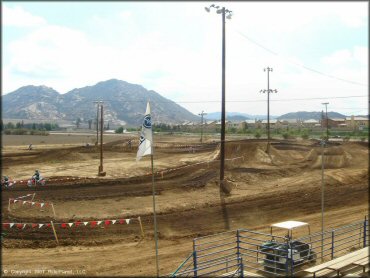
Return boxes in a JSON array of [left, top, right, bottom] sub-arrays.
[[2, 1, 369, 115]]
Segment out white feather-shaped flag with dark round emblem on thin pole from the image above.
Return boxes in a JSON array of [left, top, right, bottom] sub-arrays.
[[136, 102, 153, 161]]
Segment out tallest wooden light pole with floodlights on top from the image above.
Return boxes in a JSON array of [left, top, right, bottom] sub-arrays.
[[205, 4, 232, 186]]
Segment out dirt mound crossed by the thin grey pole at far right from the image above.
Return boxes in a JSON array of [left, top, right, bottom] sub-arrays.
[[306, 146, 352, 169]]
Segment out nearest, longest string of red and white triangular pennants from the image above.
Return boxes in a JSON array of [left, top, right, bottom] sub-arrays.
[[2, 218, 135, 230]]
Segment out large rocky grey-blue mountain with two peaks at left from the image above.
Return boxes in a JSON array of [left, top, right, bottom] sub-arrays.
[[2, 79, 198, 126]]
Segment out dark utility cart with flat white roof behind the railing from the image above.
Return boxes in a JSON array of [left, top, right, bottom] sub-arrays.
[[259, 220, 316, 273]]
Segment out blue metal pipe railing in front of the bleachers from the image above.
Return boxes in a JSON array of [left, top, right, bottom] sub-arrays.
[[170, 217, 370, 277]]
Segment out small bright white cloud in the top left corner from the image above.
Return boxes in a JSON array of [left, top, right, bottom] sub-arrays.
[[2, 5, 46, 27]]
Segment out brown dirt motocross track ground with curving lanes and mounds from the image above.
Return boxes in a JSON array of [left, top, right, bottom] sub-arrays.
[[1, 134, 369, 277]]
